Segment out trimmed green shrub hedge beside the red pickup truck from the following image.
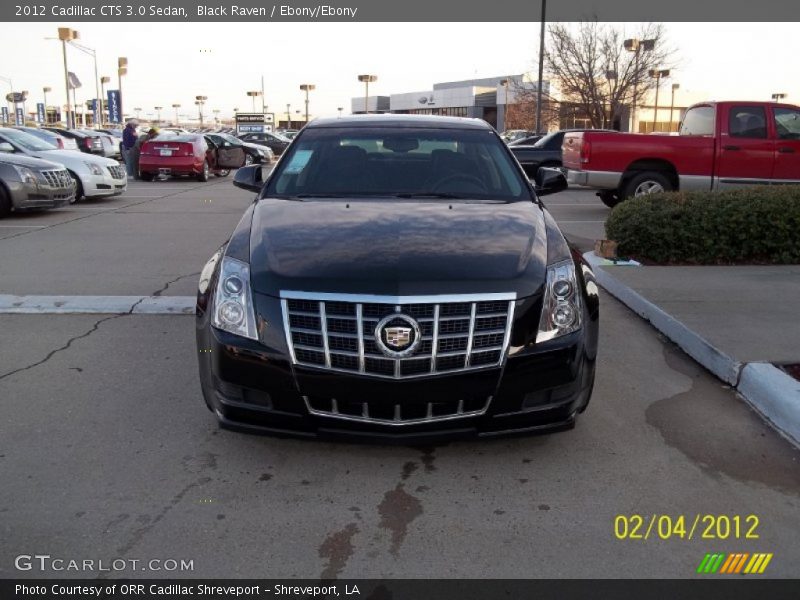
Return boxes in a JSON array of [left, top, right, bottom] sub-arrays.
[[606, 185, 800, 264]]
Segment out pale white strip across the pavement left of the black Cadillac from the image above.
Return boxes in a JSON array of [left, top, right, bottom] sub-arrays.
[[0, 294, 197, 315]]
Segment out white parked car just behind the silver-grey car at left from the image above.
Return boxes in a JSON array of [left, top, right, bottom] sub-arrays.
[[0, 127, 128, 200]]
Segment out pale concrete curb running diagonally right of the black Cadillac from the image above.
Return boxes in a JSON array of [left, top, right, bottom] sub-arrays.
[[583, 251, 800, 448]]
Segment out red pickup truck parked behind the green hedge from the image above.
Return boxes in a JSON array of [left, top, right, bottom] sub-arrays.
[[562, 102, 800, 206]]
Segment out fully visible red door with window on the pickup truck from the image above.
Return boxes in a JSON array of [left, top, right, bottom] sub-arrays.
[[717, 104, 775, 189]]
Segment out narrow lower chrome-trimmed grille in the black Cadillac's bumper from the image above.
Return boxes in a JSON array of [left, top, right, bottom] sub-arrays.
[[303, 396, 492, 425]]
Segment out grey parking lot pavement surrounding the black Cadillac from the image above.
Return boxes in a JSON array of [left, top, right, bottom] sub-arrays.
[[0, 178, 800, 578]]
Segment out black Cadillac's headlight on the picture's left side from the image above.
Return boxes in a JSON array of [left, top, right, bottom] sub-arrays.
[[211, 256, 258, 340]]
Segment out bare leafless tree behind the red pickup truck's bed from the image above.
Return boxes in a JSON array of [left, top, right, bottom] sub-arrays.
[[544, 22, 675, 128]]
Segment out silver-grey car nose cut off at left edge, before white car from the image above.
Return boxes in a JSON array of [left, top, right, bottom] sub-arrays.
[[0, 152, 75, 217]]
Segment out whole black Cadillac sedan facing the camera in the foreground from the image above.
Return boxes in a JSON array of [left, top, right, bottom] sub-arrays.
[[196, 115, 598, 441]]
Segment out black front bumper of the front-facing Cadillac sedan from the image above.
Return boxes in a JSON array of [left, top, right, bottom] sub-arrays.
[[197, 316, 594, 443]]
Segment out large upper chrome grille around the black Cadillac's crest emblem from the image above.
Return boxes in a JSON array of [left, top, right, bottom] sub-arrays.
[[281, 291, 516, 379]]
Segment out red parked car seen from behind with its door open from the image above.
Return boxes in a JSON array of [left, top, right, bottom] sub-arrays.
[[139, 135, 245, 181]]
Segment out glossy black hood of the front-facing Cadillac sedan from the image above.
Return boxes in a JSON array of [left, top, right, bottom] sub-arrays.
[[250, 199, 547, 298]]
